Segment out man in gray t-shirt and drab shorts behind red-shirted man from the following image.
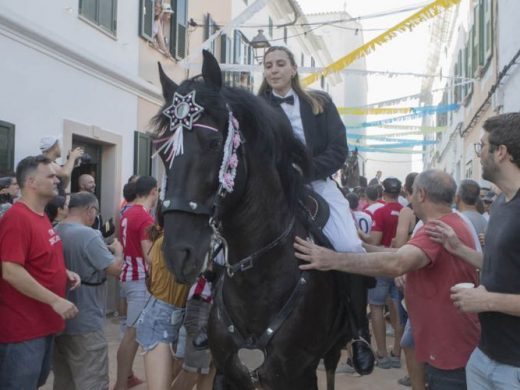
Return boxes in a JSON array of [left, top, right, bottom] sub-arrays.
[[53, 192, 123, 390]]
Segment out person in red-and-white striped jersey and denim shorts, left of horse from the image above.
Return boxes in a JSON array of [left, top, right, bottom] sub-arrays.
[[114, 176, 155, 390]]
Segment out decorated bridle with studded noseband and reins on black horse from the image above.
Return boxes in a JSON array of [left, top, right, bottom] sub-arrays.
[[153, 99, 295, 277]]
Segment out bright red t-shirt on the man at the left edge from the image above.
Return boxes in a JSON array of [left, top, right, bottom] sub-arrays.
[[0, 202, 67, 343]]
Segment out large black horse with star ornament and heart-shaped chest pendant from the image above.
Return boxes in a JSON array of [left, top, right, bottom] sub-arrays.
[[155, 52, 349, 390]]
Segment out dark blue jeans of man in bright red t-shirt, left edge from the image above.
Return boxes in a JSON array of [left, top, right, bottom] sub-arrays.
[[0, 336, 54, 390]]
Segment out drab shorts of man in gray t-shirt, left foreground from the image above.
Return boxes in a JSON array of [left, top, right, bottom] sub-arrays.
[[53, 329, 109, 390]]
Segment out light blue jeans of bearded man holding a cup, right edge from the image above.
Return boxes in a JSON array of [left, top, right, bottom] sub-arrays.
[[466, 348, 520, 390]]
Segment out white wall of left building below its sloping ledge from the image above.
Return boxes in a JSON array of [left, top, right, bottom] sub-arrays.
[[0, 35, 137, 181]]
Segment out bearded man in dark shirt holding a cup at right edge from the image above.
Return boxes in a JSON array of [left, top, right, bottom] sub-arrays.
[[430, 113, 520, 390]]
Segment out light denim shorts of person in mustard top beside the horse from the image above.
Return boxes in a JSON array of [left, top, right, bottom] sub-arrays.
[[136, 296, 184, 353]]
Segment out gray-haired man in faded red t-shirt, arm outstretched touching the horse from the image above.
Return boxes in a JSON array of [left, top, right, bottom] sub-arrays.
[[295, 170, 480, 390]]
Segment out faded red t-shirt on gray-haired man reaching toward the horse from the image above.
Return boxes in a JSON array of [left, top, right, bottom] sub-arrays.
[[405, 213, 480, 370]]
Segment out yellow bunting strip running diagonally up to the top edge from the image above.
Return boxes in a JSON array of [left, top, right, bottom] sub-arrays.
[[302, 0, 461, 86]]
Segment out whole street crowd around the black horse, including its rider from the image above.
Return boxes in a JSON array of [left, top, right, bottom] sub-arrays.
[[0, 42, 520, 390]]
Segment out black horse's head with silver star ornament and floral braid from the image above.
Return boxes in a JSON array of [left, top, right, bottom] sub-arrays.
[[154, 52, 247, 283]]
